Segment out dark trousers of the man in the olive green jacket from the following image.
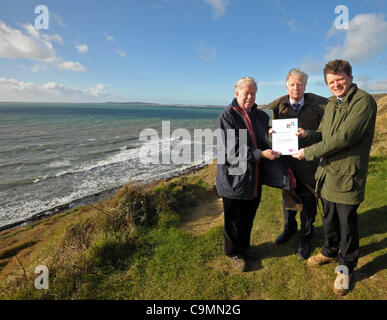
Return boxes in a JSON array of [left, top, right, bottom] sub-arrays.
[[321, 199, 359, 273]]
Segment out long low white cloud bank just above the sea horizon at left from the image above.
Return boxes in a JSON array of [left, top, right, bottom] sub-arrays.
[[0, 78, 109, 102]]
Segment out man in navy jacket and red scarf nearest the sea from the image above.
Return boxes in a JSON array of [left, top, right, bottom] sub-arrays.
[[216, 77, 281, 272]]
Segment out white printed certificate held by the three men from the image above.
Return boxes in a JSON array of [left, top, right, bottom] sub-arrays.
[[272, 118, 298, 155]]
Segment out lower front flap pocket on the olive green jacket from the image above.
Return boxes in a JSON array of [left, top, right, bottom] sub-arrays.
[[325, 164, 355, 192]]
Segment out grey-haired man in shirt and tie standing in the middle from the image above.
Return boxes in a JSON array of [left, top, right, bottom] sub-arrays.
[[269, 68, 328, 259]]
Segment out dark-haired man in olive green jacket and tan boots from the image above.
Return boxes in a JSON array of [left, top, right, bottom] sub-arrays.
[[293, 60, 376, 295]]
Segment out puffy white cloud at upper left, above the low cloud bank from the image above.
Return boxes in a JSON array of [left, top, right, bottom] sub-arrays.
[[0, 21, 86, 72]]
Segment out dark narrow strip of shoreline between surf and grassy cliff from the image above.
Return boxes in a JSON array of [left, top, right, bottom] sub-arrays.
[[0, 159, 209, 232]]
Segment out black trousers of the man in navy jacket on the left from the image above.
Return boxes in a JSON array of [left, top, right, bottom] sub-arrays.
[[223, 192, 261, 256]]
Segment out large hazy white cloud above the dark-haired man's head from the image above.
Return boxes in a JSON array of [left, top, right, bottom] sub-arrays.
[[325, 13, 387, 63]]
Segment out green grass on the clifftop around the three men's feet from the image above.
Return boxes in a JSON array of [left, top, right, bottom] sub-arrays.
[[0, 158, 387, 300]]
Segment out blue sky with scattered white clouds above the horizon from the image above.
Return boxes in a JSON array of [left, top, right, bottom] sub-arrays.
[[0, 0, 387, 105]]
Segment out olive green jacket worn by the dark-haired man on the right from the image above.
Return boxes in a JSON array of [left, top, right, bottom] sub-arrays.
[[304, 84, 376, 205]]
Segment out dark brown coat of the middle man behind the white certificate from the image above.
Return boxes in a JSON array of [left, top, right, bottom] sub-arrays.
[[269, 93, 328, 189]]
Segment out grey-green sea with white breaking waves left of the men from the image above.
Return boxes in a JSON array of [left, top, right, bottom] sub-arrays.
[[0, 102, 272, 230]]
